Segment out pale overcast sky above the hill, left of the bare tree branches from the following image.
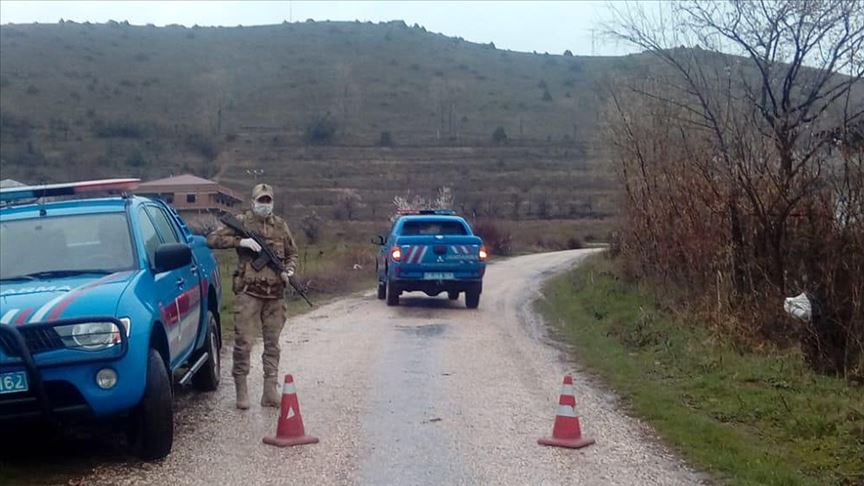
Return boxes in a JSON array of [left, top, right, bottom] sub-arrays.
[[0, 0, 656, 55]]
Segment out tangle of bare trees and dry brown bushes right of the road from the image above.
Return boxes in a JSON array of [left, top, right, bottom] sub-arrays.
[[608, 0, 864, 376]]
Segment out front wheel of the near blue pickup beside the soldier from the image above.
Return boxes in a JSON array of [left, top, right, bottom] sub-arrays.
[[129, 348, 174, 461]]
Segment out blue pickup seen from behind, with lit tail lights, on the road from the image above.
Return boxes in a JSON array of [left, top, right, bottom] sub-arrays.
[[373, 210, 487, 309]]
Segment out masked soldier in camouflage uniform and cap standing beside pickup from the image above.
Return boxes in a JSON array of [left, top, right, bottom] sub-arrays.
[[207, 184, 297, 410]]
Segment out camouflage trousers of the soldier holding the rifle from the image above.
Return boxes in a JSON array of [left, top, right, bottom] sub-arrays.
[[231, 293, 288, 378]]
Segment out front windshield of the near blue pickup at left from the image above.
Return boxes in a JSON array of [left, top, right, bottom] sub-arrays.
[[0, 213, 135, 280]]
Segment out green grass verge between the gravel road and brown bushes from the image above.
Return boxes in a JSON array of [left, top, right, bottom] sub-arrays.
[[537, 257, 864, 485]]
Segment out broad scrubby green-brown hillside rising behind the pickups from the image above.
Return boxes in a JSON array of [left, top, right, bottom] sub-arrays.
[[0, 22, 649, 235]]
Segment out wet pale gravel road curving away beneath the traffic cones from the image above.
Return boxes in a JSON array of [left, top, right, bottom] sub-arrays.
[[3, 250, 704, 485]]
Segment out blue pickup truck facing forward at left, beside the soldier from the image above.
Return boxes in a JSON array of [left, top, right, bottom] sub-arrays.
[[0, 179, 221, 459]]
